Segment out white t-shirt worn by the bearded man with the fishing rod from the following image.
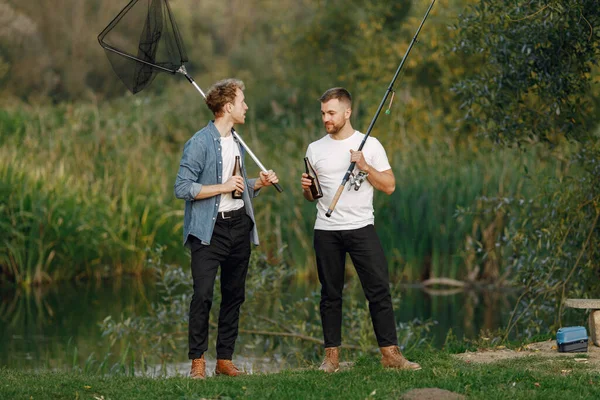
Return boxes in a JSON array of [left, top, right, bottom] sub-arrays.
[[306, 131, 392, 231]]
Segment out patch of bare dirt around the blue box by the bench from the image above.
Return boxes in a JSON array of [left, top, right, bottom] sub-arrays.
[[455, 340, 600, 370]]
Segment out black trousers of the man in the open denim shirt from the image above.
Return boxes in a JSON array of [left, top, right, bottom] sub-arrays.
[[188, 214, 254, 360]]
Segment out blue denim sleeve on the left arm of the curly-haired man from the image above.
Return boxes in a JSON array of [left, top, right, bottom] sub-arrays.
[[175, 140, 205, 201]]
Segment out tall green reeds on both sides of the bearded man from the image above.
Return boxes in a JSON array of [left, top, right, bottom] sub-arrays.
[[245, 128, 560, 282]]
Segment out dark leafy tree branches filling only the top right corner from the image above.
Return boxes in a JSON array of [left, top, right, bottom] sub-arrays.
[[454, 0, 600, 143]]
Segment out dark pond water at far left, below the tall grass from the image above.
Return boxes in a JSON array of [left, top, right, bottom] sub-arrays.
[[0, 279, 156, 368]]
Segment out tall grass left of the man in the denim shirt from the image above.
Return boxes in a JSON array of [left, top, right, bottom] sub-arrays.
[[0, 98, 185, 284]]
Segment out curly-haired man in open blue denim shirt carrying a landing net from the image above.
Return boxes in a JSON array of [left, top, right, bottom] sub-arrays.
[[175, 79, 279, 379]]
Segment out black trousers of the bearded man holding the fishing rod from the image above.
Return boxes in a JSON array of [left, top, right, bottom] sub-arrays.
[[314, 225, 398, 347]]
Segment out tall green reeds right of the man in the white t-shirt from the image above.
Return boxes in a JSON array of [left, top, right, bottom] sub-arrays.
[[376, 142, 556, 281]]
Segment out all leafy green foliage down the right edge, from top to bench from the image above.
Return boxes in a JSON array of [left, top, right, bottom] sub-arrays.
[[454, 0, 600, 334]]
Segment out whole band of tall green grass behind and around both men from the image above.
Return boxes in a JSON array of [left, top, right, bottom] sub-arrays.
[[0, 91, 568, 284]]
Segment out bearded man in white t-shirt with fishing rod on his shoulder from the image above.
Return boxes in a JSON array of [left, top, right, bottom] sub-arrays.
[[301, 88, 421, 372]]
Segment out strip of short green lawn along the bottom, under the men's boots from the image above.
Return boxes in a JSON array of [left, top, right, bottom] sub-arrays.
[[0, 352, 600, 400]]
